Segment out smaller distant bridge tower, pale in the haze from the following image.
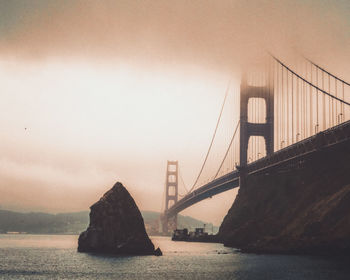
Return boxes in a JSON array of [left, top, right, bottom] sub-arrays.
[[162, 160, 179, 233]]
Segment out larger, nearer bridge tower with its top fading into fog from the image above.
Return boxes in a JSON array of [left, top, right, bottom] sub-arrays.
[[240, 70, 274, 167]]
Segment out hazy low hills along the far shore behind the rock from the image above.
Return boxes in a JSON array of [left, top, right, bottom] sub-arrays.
[[0, 210, 218, 235]]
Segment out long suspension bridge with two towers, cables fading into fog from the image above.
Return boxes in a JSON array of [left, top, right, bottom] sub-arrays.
[[161, 55, 350, 232]]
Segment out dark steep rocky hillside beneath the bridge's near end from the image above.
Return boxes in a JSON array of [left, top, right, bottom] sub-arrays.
[[219, 139, 350, 254]]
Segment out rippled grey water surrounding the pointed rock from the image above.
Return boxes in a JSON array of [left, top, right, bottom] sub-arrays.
[[0, 235, 350, 280]]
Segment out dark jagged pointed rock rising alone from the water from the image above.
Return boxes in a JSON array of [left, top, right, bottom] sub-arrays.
[[78, 182, 161, 256]]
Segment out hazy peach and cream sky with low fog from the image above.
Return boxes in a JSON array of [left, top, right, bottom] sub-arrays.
[[0, 0, 350, 223]]
